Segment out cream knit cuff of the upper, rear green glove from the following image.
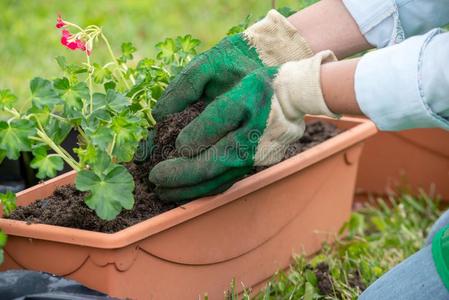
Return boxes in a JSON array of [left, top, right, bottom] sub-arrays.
[[243, 9, 313, 66]]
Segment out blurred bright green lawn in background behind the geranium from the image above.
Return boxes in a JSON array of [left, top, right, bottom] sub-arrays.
[[0, 0, 304, 98]]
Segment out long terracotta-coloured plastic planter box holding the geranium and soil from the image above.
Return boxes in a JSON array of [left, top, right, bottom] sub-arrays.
[[0, 118, 376, 299]]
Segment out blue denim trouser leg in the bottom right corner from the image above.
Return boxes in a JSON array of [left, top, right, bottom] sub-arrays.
[[359, 211, 449, 300]]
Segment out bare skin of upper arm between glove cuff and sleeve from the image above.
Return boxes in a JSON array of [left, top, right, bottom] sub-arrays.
[[288, 0, 372, 59]]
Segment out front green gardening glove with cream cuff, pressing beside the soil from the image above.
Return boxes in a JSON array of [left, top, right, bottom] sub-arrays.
[[150, 51, 337, 201]]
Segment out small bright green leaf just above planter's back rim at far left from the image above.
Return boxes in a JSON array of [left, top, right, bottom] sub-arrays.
[[30, 147, 64, 179]]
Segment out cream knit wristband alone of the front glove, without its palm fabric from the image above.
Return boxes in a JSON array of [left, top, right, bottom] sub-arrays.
[[273, 50, 339, 120]]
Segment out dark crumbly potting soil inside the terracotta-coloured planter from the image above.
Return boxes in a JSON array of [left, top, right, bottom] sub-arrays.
[[9, 102, 340, 233]]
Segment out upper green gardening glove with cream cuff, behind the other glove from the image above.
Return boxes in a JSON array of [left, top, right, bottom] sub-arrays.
[[137, 10, 313, 161]]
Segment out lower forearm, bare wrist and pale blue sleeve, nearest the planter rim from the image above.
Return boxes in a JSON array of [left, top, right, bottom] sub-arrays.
[[320, 30, 449, 130]]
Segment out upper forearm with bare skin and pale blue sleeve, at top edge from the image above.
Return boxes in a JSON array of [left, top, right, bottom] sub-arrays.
[[288, 0, 449, 59]]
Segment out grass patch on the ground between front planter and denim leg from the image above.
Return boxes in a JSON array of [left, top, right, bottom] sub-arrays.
[[227, 194, 441, 300]]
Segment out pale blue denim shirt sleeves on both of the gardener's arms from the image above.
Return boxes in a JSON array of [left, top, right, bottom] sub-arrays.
[[343, 0, 449, 130]]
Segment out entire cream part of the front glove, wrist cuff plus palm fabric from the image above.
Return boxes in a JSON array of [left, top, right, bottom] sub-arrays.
[[254, 51, 338, 166]]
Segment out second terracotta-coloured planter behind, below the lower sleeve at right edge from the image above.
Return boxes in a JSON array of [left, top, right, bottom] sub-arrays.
[[356, 129, 449, 201]]
